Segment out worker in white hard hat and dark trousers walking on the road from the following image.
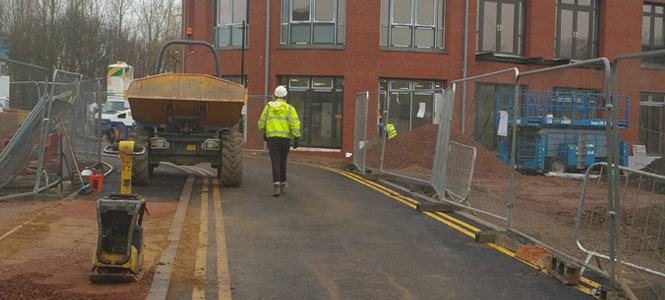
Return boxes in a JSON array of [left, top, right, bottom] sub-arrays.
[[259, 85, 300, 197]]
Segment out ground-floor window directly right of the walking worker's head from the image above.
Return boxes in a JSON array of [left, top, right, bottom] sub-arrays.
[[280, 76, 344, 149]]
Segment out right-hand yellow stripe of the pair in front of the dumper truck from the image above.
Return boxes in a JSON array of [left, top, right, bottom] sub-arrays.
[[213, 178, 231, 300]]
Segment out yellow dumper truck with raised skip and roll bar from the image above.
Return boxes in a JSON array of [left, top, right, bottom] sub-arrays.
[[127, 41, 247, 186]]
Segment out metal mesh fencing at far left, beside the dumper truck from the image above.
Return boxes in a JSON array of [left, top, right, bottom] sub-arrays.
[[0, 60, 103, 200]]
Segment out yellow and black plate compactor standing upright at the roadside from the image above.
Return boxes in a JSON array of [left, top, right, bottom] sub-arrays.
[[90, 141, 146, 282]]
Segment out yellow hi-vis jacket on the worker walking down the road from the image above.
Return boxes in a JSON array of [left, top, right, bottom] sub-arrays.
[[259, 98, 300, 138]]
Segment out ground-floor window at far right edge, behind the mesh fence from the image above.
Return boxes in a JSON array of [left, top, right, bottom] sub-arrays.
[[639, 93, 665, 155]]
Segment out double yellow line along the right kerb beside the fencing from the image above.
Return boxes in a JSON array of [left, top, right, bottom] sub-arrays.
[[308, 162, 600, 299]]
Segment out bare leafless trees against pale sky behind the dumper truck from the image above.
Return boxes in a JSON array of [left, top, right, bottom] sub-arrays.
[[0, 0, 180, 79]]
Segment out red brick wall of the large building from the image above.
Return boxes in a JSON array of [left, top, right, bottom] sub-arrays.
[[187, 0, 665, 156]]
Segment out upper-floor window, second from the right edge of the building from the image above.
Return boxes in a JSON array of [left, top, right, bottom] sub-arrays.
[[555, 0, 599, 59]]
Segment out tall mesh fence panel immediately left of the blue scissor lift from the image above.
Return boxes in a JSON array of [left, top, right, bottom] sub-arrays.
[[432, 68, 519, 224]]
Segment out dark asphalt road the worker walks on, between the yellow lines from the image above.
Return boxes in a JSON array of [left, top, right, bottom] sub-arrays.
[[102, 158, 590, 299]]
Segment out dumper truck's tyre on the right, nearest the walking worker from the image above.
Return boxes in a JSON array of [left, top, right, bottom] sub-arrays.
[[217, 130, 242, 187]]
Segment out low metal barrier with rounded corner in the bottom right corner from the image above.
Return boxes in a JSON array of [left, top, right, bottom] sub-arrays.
[[574, 162, 665, 299]]
